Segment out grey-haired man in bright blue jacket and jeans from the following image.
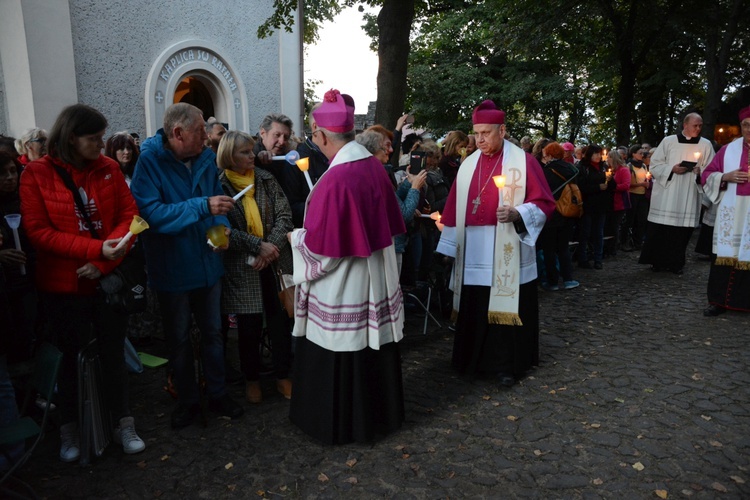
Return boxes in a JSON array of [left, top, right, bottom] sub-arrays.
[[130, 103, 243, 429]]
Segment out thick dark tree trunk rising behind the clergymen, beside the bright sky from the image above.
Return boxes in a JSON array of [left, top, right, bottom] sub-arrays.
[[375, 0, 415, 129]]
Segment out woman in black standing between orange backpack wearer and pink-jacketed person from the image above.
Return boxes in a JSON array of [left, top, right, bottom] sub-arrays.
[[578, 144, 615, 269]]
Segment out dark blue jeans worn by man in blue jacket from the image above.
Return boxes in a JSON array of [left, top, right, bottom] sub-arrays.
[[157, 281, 226, 405]]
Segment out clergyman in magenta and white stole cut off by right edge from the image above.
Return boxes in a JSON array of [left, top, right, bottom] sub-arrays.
[[701, 106, 750, 316]]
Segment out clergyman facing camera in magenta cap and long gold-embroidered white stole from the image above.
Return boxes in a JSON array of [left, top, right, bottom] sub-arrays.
[[438, 100, 555, 386]]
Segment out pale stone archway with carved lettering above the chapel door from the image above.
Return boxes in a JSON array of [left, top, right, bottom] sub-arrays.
[[146, 40, 250, 136]]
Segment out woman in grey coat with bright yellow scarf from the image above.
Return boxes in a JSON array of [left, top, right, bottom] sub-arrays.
[[216, 131, 293, 403]]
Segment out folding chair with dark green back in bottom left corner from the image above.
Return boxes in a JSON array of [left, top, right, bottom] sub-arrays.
[[0, 342, 62, 498]]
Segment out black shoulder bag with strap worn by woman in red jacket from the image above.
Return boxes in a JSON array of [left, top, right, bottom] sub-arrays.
[[54, 165, 148, 314]]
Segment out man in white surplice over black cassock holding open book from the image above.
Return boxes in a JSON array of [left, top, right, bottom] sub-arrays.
[[638, 113, 714, 274]]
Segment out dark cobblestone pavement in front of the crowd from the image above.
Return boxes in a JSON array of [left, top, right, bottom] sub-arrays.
[[10, 241, 750, 499]]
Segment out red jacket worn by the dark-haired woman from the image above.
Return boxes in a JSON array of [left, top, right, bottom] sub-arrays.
[[20, 155, 138, 295]]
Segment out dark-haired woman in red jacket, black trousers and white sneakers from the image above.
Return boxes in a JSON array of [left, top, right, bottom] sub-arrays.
[[20, 104, 145, 462]]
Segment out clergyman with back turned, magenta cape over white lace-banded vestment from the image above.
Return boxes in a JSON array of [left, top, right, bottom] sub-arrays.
[[289, 90, 406, 444]]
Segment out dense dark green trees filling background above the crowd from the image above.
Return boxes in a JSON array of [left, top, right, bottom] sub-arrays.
[[259, 0, 750, 146]]
